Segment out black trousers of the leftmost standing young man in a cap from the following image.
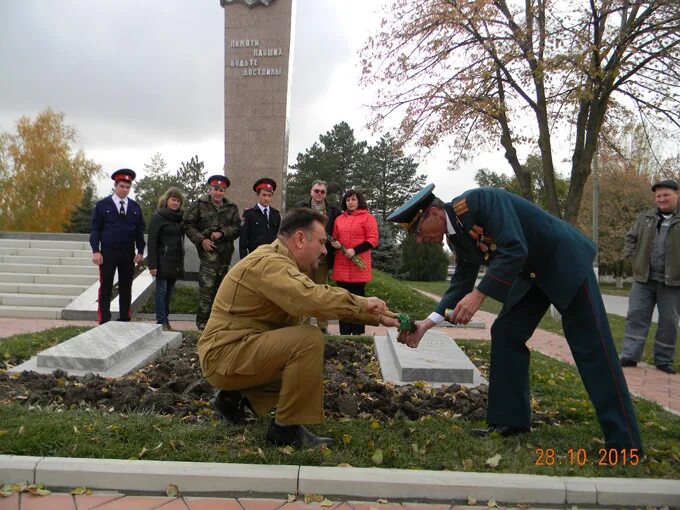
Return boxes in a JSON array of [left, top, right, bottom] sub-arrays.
[[97, 246, 135, 324]]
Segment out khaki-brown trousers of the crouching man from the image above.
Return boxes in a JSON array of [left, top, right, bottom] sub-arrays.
[[206, 325, 324, 425]]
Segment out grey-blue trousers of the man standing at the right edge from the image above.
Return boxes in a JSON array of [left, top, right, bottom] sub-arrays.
[[621, 281, 680, 366]]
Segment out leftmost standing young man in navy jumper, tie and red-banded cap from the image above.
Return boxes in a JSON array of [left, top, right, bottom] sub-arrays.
[[90, 168, 146, 324]]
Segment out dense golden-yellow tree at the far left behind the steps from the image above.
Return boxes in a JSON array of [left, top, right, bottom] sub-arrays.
[[0, 108, 101, 232]]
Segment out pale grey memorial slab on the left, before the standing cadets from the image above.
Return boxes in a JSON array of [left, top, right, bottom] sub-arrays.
[[9, 321, 182, 377]]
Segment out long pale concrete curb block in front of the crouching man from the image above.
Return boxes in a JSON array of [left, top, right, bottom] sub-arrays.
[[35, 457, 299, 494]]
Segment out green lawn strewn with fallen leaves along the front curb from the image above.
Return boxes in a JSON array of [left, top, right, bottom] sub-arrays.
[[0, 328, 680, 479]]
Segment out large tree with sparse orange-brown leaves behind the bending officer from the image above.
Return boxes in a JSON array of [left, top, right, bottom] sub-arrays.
[[362, 0, 680, 223]]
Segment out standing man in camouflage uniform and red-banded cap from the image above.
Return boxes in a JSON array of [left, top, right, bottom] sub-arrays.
[[184, 175, 241, 331]]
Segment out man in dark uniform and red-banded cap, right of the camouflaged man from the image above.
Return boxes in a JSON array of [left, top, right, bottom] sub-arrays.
[[238, 177, 281, 258]]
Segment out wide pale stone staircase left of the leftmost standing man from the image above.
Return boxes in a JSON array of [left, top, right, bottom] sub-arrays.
[[0, 233, 99, 319]]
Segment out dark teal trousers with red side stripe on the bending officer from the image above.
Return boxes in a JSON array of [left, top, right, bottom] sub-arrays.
[[487, 273, 642, 449]]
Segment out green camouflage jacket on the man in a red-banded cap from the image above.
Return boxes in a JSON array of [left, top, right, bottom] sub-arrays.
[[184, 194, 241, 256]]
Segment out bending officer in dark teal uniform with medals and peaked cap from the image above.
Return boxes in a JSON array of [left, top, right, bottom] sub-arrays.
[[388, 184, 642, 454]]
